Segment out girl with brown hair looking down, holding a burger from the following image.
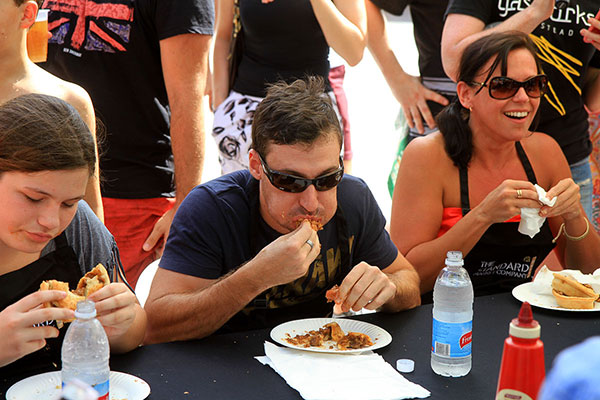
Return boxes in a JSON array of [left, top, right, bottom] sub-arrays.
[[0, 94, 146, 384]]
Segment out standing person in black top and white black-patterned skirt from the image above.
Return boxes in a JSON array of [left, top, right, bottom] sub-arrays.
[[212, 0, 366, 174]]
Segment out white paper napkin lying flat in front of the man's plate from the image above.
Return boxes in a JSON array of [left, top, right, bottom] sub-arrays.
[[256, 342, 430, 400]]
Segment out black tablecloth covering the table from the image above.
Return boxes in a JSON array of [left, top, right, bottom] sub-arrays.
[[0, 293, 600, 400]]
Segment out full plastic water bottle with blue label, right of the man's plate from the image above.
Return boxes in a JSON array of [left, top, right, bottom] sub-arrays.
[[431, 251, 473, 377]]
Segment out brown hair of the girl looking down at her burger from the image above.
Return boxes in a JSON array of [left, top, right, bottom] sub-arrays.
[[0, 94, 96, 176]]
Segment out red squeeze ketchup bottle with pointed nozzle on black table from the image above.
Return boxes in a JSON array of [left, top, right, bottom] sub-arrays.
[[496, 302, 546, 400]]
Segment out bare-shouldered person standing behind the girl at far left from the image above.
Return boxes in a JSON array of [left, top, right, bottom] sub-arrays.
[[0, 0, 104, 220]]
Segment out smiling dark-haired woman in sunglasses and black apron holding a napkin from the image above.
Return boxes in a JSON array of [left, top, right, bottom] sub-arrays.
[[391, 32, 600, 301]]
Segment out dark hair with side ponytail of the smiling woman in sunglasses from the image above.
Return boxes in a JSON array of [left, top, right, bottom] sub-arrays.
[[436, 31, 542, 168]]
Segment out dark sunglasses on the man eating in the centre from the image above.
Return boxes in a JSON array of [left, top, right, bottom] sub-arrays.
[[258, 154, 344, 193]]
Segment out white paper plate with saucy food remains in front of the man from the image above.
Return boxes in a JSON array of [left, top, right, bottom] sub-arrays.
[[271, 318, 392, 354]]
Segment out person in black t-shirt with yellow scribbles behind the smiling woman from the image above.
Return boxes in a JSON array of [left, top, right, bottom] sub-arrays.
[[442, 0, 600, 218]]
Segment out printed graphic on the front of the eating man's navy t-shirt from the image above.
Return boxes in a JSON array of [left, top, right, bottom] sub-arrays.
[[258, 236, 354, 308]]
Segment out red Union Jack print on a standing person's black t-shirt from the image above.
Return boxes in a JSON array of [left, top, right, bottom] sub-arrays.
[[43, 0, 133, 56]]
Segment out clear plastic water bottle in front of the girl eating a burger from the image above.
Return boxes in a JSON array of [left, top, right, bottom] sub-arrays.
[[62, 300, 110, 400]]
